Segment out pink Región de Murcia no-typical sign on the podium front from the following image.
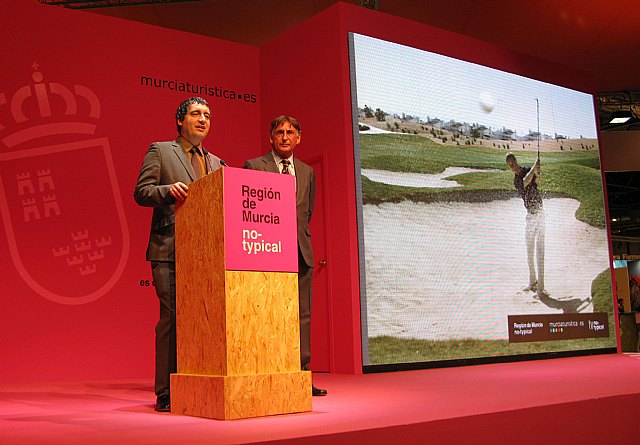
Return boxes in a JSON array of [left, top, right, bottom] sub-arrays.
[[224, 168, 298, 272]]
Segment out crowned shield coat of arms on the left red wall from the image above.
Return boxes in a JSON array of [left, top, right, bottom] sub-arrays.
[[0, 62, 129, 305]]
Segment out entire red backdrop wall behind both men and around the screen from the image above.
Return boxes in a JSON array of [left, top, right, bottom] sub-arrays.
[[0, 2, 604, 380]]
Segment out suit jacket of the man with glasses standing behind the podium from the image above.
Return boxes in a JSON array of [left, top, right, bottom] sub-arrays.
[[243, 152, 316, 267]]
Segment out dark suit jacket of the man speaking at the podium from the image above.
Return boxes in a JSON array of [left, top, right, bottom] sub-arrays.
[[133, 140, 221, 261]]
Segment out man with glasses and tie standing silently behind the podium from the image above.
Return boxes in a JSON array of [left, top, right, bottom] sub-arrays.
[[244, 116, 327, 396]]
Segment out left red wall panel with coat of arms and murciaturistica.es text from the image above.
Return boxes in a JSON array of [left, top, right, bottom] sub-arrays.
[[0, 2, 260, 380]]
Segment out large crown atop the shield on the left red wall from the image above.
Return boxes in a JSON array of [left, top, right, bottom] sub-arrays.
[[0, 62, 101, 148]]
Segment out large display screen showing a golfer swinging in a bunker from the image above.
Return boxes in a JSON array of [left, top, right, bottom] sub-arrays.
[[349, 34, 616, 371]]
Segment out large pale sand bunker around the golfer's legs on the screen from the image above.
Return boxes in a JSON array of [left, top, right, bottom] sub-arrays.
[[363, 198, 609, 340]]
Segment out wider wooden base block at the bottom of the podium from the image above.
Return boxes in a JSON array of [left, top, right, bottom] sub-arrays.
[[171, 371, 311, 420]]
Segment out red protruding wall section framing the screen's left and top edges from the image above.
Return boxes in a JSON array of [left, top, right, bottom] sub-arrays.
[[260, 3, 593, 373]]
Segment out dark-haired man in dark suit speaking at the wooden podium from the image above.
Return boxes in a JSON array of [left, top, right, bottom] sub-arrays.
[[133, 97, 224, 412]]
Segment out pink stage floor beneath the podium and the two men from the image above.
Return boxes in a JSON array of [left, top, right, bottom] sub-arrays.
[[0, 354, 640, 445]]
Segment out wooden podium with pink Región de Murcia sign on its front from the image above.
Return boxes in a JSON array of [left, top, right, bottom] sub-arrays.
[[171, 167, 311, 419]]
